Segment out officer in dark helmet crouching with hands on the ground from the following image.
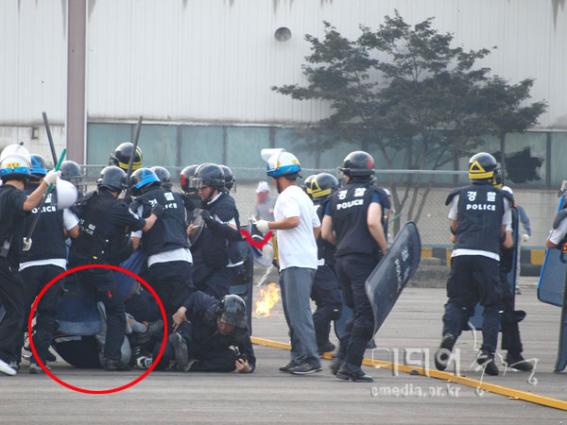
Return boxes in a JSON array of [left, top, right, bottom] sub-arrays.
[[172, 291, 256, 373]]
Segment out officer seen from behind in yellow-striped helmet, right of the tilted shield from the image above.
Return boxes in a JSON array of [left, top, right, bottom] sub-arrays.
[[435, 152, 513, 375]]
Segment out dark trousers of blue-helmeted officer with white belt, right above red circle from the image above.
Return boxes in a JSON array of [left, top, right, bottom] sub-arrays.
[[148, 261, 195, 325]]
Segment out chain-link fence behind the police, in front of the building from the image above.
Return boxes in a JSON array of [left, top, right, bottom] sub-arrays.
[[84, 165, 557, 248]]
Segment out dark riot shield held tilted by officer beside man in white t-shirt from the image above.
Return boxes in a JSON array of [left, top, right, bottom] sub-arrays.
[[366, 221, 421, 333]]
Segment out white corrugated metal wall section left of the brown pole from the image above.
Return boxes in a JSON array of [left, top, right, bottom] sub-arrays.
[[0, 0, 67, 126]]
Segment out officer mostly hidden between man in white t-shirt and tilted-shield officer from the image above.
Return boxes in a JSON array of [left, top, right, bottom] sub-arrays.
[[305, 173, 342, 353]]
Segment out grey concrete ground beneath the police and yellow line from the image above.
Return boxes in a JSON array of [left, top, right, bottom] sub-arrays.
[[0, 281, 567, 425]]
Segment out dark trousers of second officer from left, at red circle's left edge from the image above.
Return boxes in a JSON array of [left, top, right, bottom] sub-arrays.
[[20, 265, 65, 361]]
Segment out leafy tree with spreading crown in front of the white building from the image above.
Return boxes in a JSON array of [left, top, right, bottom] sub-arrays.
[[272, 11, 545, 231]]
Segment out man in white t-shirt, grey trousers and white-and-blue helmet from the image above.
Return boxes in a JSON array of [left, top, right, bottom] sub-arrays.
[[256, 151, 321, 375]]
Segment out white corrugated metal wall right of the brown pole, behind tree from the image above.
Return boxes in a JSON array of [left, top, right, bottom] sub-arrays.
[[88, 0, 567, 128]]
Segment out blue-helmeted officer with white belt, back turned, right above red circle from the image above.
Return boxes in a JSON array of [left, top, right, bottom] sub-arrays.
[[130, 168, 193, 332]]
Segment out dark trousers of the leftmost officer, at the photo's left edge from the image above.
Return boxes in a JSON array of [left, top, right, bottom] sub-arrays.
[[0, 258, 25, 363]]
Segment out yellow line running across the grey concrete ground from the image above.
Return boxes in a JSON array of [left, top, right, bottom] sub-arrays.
[[252, 337, 567, 411]]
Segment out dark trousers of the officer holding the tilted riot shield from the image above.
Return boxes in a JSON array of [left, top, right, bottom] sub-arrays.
[[336, 255, 380, 371]]
